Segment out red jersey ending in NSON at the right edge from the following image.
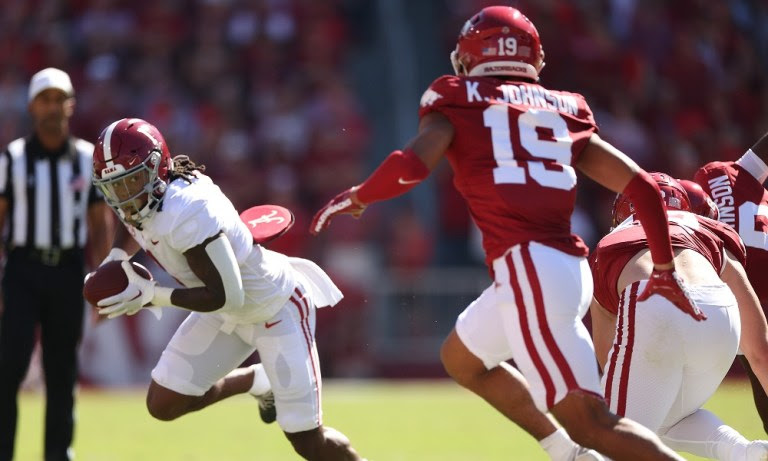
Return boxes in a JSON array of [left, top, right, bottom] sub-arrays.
[[694, 162, 768, 308]]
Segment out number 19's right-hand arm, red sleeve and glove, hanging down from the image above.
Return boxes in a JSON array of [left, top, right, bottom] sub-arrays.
[[575, 134, 707, 320]]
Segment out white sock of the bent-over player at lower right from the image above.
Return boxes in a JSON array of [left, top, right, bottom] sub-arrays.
[[661, 409, 749, 461]]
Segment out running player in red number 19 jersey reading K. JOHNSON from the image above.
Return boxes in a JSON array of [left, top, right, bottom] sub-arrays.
[[310, 6, 704, 459]]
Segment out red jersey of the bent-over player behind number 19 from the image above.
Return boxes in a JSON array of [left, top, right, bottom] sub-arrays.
[[589, 211, 746, 314]]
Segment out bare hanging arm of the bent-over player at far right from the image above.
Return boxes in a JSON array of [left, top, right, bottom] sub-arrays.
[[720, 255, 768, 392]]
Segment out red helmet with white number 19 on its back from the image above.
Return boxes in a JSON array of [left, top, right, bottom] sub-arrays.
[[451, 6, 544, 81]]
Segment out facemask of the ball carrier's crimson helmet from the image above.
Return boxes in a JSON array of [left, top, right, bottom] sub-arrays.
[[93, 149, 167, 229]]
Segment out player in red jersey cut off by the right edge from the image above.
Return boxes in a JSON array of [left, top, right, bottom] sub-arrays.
[[694, 135, 768, 433]]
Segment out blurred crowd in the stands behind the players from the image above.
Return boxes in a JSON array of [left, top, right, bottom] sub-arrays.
[[6, 0, 768, 380]]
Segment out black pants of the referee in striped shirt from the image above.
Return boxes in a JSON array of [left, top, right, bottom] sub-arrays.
[[0, 249, 84, 461]]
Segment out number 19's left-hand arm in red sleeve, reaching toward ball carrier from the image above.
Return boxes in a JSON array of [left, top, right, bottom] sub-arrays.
[[309, 112, 453, 235]]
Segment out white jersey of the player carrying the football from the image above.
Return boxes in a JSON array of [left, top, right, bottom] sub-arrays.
[[127, 173, 297, 324]]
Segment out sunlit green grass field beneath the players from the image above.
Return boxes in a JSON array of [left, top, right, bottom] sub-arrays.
[[16, 381, 765, 461]]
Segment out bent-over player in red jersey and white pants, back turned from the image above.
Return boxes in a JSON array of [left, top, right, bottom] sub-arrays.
[[590, 173, 768, 460]]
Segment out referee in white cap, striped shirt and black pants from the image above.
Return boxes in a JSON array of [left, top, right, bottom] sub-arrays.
[[0, 68, 111, 461]]
